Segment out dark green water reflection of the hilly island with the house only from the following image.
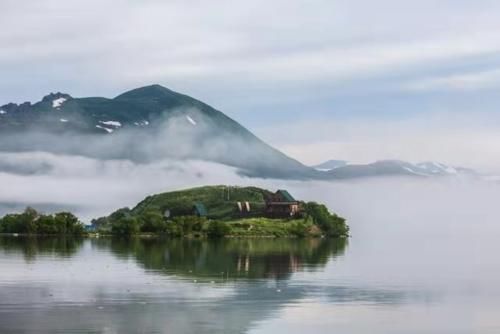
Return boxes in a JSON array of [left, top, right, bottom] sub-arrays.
[[98, 239, 347, 281]]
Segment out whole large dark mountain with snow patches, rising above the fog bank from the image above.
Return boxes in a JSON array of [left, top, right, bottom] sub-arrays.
[[0, 85, 318, 179]]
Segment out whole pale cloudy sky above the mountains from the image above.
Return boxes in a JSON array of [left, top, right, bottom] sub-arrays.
[[0, 0, 500, 172]]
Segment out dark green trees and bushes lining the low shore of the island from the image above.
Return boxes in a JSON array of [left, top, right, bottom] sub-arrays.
[[0, 202, 349, 238]]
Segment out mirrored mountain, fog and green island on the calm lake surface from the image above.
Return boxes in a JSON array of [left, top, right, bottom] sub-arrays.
[[0, 238, 410, 333]]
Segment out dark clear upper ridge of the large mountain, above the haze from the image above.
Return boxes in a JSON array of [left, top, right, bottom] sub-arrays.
[[0, 85, 266, 136]]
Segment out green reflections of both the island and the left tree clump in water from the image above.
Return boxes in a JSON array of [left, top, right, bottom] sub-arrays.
[[0, 236, 347, 282]]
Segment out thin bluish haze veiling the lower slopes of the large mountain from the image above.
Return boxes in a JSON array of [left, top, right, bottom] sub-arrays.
[[0, 107, 314, 178]]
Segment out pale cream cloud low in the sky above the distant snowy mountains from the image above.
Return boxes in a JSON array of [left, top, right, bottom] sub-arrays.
[[259, 110, 500, 173]]
